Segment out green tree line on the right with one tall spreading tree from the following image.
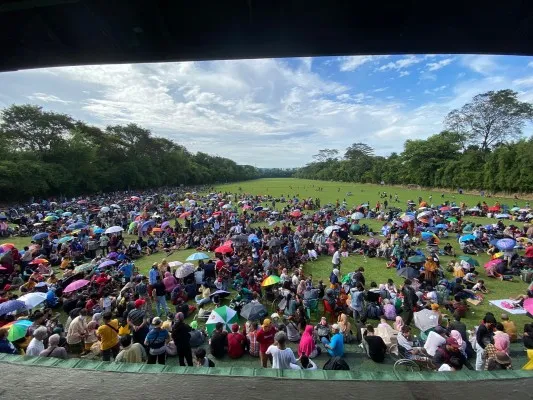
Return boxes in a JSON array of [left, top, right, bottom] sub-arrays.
[[295, 90, 533, 193]]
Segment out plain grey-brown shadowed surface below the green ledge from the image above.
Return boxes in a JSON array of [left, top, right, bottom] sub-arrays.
[[0, 364, 533, 400]]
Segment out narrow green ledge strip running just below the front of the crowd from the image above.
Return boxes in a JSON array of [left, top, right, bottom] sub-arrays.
[[0, 354, 533, 382]]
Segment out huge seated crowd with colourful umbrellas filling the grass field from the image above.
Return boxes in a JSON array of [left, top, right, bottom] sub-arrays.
[[0, 187, 533, 371]]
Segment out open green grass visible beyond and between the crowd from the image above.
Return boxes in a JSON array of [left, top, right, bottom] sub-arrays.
[[0, 179, 530, 328]]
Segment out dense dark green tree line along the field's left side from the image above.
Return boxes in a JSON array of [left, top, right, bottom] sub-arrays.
[[0, 105, 266, 201]]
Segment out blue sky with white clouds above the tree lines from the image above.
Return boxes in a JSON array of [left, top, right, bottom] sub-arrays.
[[0, 55, 533, 168]]
